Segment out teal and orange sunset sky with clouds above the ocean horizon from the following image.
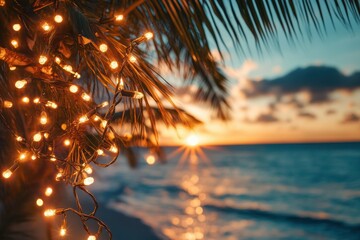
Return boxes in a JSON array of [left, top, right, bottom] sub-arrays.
[[156, 8, 360, 145]]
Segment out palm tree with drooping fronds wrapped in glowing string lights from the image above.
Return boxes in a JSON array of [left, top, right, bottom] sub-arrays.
[[0, 0, 360, 237]]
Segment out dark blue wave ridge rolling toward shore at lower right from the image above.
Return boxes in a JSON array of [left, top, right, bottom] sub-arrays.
[[204, 204, 360, 233]]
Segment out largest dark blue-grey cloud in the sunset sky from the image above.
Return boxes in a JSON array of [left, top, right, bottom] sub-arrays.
[[242, 66, 360, 103]]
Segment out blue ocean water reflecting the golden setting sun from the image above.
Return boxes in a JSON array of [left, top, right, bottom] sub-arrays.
[[94, 143, 360, 240]]
